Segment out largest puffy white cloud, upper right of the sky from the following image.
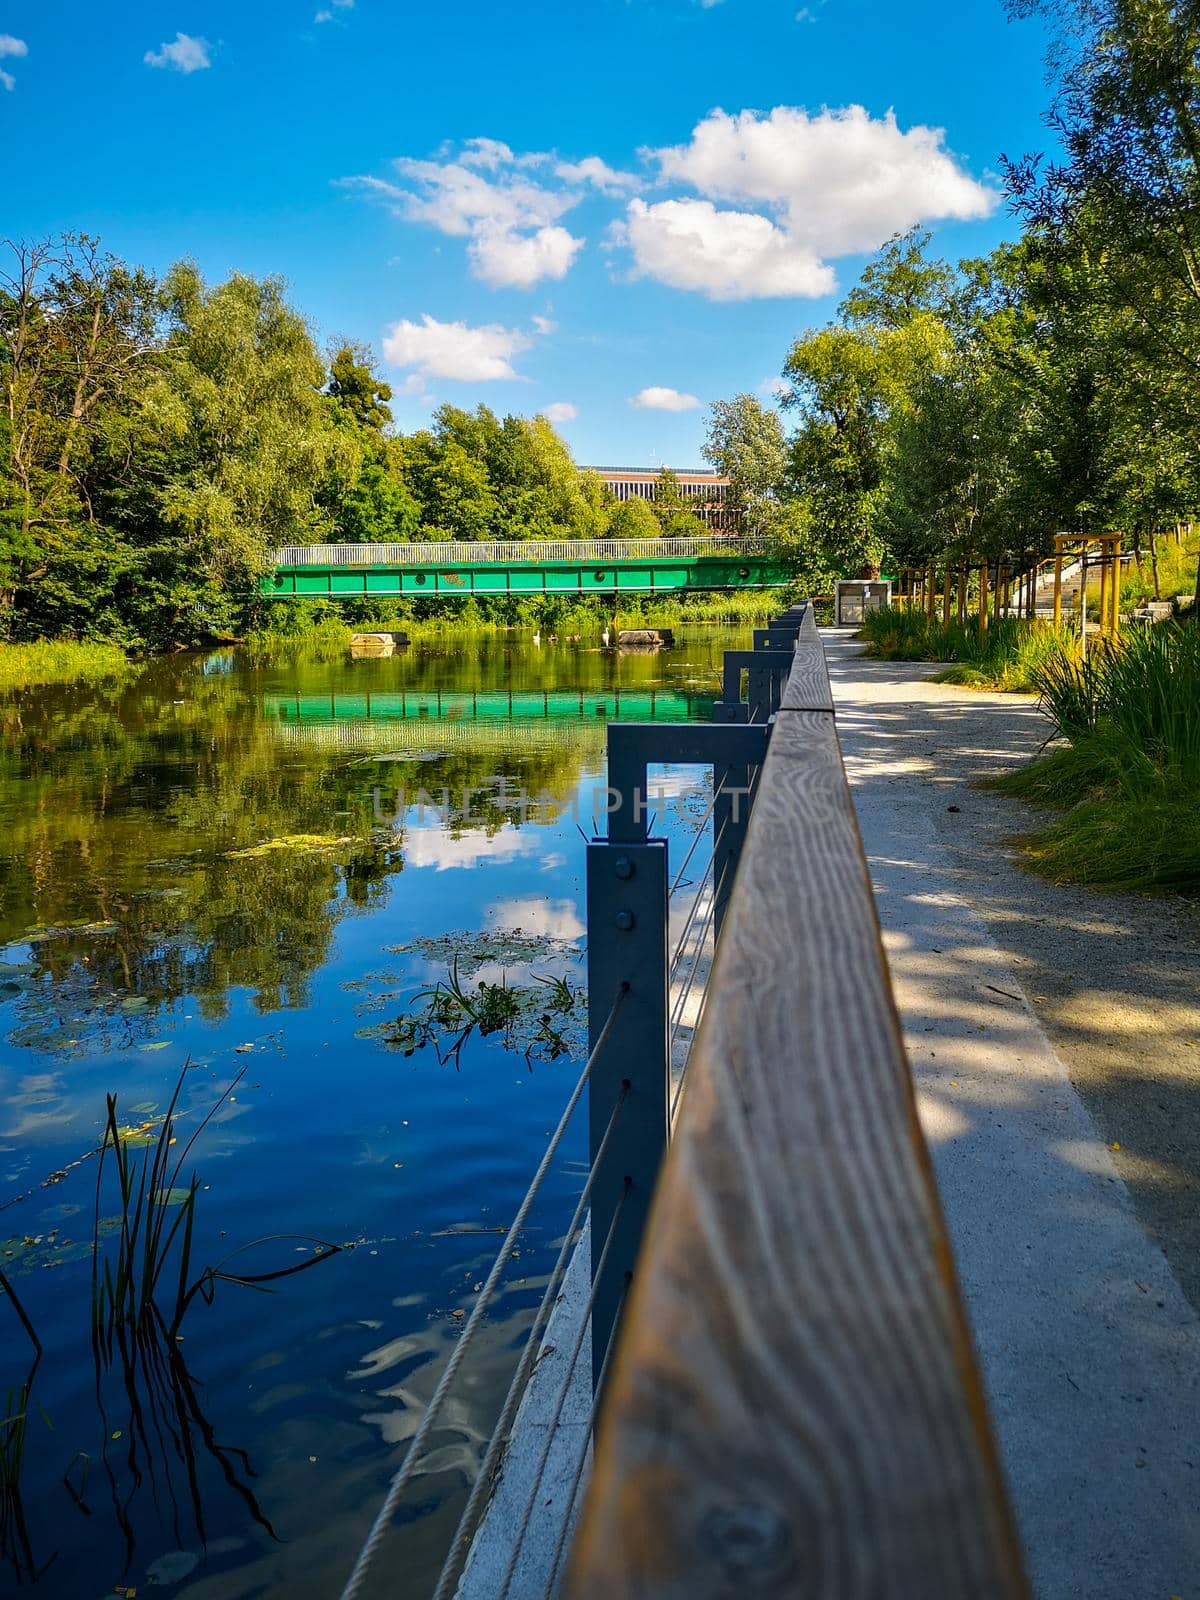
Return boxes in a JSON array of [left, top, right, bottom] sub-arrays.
[[650, 106, 1000, 256]]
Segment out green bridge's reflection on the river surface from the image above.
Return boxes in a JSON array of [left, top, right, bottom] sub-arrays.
[[262, 688, 715, 750]]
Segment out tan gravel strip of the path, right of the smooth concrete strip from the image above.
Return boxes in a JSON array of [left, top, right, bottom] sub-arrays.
[[826, 634, 1200, 1310]]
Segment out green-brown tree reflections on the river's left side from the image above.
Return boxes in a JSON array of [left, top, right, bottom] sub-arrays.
[[0, 658, 604, 1048]]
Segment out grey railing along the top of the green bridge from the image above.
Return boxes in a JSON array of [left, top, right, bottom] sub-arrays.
[[272, 534, 765, 568]]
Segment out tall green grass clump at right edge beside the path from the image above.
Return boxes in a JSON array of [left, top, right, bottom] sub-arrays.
[[994, 622, 1200, 894]]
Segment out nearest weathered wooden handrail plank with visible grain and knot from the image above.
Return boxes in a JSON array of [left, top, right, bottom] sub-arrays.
[[566, 645, 1027, 1600]]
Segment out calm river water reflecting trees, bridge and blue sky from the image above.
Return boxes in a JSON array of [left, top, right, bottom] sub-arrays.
[[0, 629, 747, 1600]]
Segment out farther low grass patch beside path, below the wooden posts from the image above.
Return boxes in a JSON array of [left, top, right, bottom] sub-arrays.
[[862, 606, 1066, 693]]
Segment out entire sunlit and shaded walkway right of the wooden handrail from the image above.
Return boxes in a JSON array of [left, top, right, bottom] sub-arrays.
[[826, 634, 1200, 1600]]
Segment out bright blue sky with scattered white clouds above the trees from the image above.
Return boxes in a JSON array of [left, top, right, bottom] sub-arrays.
[[0, 0, 1046, 466]]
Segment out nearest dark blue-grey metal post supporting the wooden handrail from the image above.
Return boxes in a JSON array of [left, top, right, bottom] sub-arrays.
[[587, 838, 670, 1386]]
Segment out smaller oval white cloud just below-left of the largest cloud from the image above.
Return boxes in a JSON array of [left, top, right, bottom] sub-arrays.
[[616, 200, 835, 301]]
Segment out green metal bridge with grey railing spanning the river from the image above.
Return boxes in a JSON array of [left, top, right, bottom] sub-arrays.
[[259, 534, 789, 600]]
